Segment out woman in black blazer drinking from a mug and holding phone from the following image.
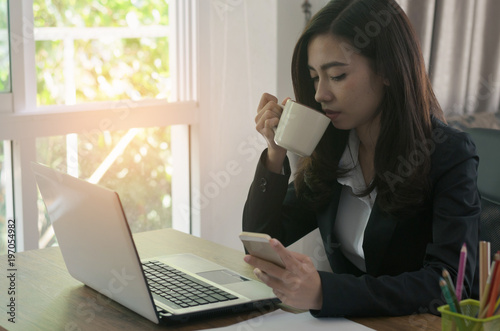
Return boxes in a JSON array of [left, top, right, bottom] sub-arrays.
[[243, 0, 480, 317]]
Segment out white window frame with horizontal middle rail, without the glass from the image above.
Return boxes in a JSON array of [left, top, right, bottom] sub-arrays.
[[0, 0, 199, 251]]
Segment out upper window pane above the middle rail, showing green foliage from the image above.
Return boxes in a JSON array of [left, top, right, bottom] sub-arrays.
[[33, 0, 171, 105]]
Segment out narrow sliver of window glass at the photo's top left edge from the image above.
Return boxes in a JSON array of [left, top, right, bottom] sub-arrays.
[[0, 0, 10, 92]]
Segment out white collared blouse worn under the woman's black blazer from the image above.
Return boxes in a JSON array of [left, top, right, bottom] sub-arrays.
[[333, 129, 377, 271]]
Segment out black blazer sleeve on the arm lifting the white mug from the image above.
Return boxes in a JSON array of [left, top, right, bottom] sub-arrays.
[[243, 150, 317, 246]]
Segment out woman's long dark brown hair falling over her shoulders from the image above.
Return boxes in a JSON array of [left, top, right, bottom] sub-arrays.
[[292, 0, 444, 213]]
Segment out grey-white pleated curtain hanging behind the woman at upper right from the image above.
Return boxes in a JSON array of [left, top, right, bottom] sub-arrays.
[[398, 0, 500, 116]]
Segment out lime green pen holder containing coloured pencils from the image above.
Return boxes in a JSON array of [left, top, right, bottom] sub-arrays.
[[438, 299, 500, 331]]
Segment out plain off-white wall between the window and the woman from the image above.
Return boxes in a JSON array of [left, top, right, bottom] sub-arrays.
[[195, 0, 326, 249]]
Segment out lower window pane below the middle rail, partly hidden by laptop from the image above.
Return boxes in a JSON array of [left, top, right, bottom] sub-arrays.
[[36, 127, 172, 248]]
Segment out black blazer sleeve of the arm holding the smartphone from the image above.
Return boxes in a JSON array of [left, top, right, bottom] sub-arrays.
[[311, 128, 481, 317]]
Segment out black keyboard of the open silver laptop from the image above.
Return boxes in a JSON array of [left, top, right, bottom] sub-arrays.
[[142, 261, 238, 309]]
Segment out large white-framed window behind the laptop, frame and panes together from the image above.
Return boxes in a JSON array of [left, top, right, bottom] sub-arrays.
[[0, 0, 198, 250]]
